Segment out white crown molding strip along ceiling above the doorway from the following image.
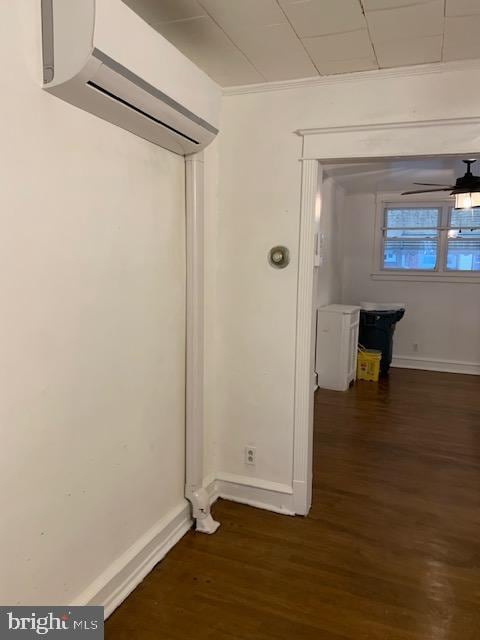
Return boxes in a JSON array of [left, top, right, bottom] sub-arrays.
[[222, 59, 480, 96]]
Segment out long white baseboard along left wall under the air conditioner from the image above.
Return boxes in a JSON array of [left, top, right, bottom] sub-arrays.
[[71, 500, 192, 618]]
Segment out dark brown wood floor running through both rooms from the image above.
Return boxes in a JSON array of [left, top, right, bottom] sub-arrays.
[[106, 369, 480, 640]]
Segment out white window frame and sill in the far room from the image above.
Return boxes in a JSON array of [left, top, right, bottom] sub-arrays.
[[370, 193, 480, 283]]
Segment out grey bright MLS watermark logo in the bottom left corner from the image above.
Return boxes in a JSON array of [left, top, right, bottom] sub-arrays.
[[0, 606, 104, 640]]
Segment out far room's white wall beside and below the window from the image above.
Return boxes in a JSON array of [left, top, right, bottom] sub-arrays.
[[342, 193, 480, 367]]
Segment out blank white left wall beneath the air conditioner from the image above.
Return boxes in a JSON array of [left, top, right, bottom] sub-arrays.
[[0, 0, 185, 604]]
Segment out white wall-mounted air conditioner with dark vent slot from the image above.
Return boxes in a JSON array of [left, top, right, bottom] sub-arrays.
[[41, 0, 221, 155]]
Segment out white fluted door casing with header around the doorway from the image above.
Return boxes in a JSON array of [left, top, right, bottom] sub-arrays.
[[293, 118, 480, 513]]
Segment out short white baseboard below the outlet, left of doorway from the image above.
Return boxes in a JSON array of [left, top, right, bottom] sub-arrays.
[[207, 473, 295, 516]]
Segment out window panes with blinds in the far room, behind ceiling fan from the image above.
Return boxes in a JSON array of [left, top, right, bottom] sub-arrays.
[[380, 202, 480, 274]]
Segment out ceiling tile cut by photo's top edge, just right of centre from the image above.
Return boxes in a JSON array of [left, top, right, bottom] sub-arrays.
[[279, 0, 365, 38]]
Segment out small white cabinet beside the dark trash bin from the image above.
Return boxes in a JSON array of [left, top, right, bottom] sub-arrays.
[[315, 304, 360, 391]]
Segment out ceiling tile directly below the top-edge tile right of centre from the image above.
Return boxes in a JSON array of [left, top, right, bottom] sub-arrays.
[[303, 29, 375, 64]]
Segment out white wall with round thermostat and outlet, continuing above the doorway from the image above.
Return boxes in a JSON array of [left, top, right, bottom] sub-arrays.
[[207, 65, 479, 485]]
